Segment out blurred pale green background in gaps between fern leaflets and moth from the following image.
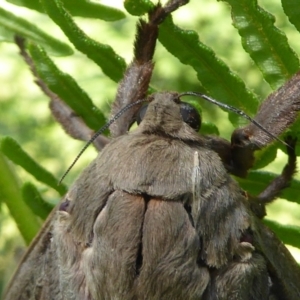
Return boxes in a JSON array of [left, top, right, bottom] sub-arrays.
[[0, 0, 300, 295]]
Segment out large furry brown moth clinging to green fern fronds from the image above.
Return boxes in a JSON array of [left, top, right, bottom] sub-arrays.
[[5, 0, 300, 300]]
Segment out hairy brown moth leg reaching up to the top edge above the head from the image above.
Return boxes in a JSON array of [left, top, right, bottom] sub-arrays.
[[110, 0, 188, 137]]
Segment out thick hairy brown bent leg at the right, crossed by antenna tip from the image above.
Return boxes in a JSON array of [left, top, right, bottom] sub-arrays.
[[231, 72, 300, 177]]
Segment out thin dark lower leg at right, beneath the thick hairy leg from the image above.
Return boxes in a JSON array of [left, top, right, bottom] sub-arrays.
[[250, 136, 297, 219]]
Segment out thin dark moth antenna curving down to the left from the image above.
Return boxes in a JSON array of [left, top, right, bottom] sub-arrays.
[[58, 99, 146, 185]]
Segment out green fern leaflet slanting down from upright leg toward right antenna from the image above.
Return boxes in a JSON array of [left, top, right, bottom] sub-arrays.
[[159, 18, 258, 125]]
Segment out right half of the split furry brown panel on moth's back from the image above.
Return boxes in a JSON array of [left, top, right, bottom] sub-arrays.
[[135, 197, 209, 300]]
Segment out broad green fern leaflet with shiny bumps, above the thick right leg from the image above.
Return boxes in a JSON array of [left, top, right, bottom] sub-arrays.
[[224, 0, 299, 89]]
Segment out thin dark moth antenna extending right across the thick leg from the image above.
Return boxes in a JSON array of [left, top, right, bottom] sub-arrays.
[[179, 92, 290, 147]]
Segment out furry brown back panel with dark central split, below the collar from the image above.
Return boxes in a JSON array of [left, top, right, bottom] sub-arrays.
[[66, 190, 209, 300]]
